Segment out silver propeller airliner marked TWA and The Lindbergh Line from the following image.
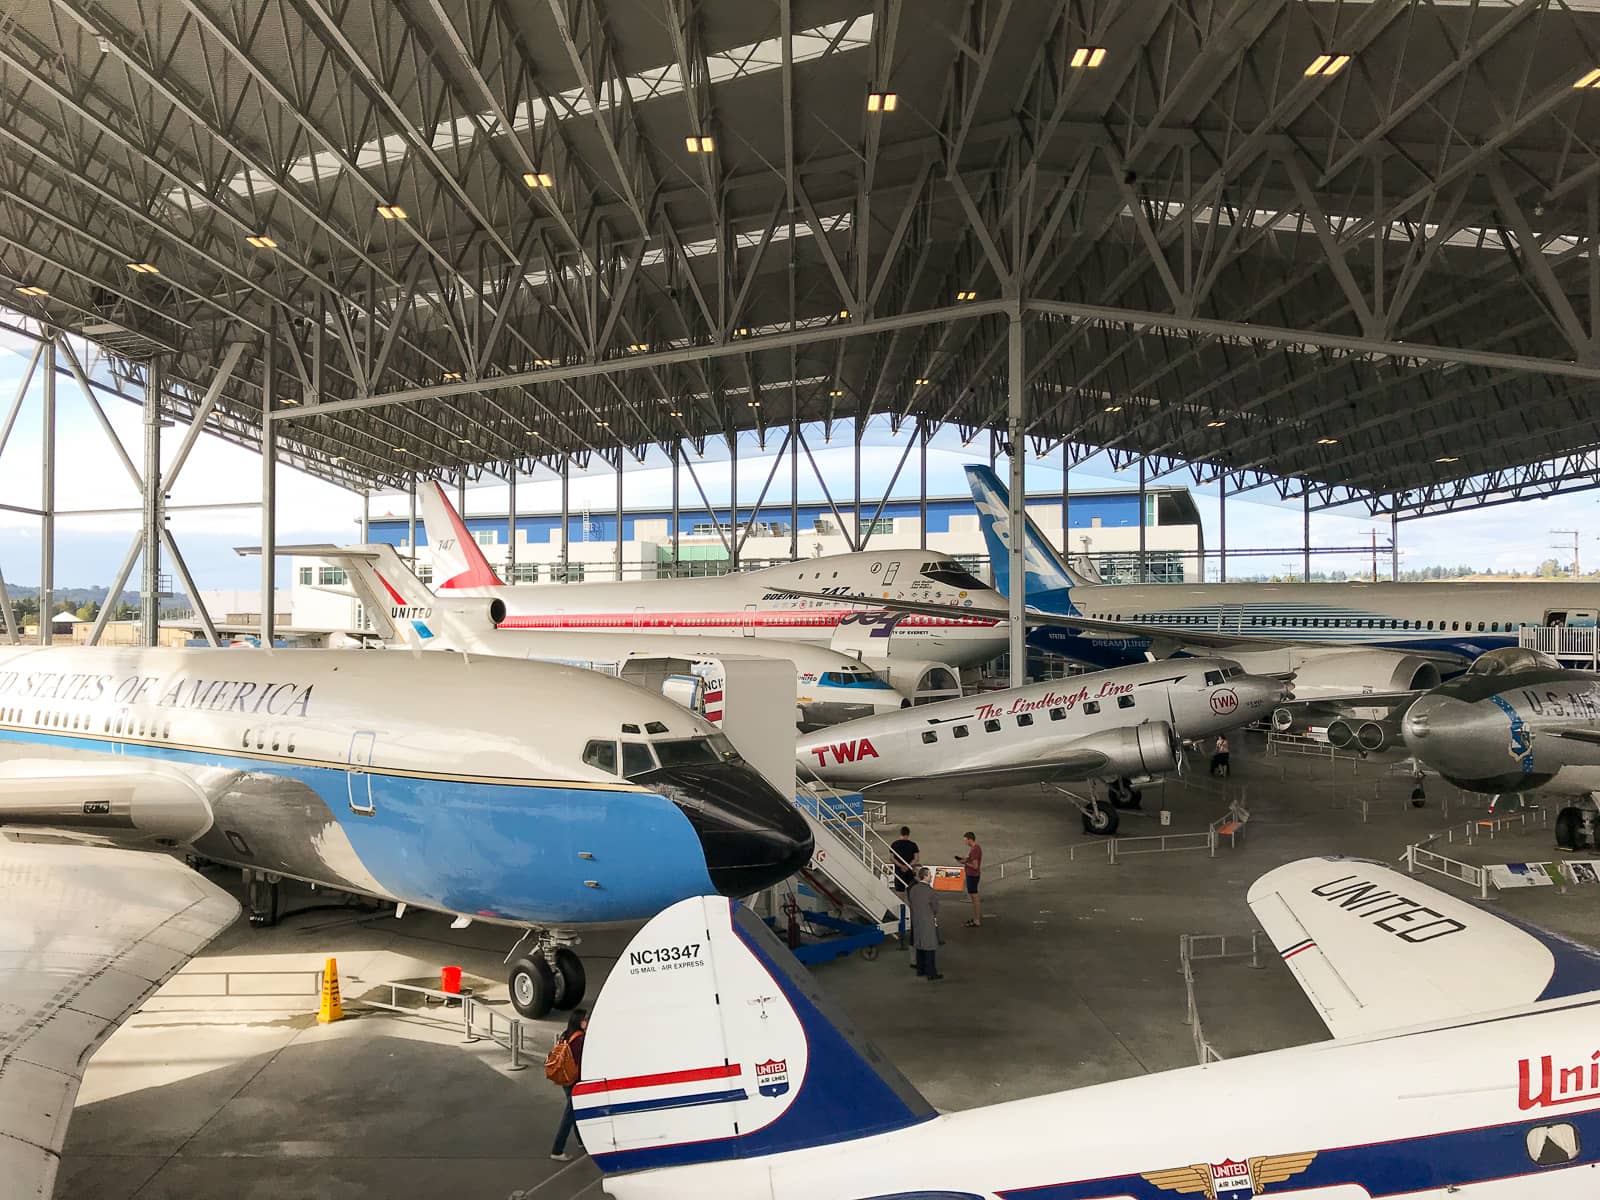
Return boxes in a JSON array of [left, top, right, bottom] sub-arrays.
[[795, 658, 1283, 835]]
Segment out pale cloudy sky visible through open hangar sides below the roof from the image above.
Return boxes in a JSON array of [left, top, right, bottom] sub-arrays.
[[0, 329, 1600, 590]]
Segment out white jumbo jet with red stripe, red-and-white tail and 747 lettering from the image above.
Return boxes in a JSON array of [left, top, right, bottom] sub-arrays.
[[419, 483, 1006, 701]]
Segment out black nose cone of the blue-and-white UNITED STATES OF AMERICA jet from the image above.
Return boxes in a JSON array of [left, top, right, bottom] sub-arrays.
[[635, 762, 811, 896]]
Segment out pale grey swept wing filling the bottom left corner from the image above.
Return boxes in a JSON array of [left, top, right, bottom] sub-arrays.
[[0, 840, 238, 1197]]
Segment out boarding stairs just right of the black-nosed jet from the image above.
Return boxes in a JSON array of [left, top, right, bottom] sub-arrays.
[[795, 779, 902, 934]]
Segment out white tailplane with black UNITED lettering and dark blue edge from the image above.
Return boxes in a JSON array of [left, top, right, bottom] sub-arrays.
[[1250, 858, 1600, 1037]]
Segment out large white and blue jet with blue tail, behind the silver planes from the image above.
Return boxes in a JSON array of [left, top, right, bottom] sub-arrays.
[[953, 466, 1597, 750]]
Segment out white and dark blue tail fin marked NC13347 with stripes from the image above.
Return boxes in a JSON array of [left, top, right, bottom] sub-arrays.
[[573, 896, 934, 1174]]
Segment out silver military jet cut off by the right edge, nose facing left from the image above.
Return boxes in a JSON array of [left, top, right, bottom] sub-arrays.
[[1402, 646, 1600, 850]]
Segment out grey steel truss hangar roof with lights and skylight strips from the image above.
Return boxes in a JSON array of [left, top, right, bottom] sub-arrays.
[[0, 0, 1600, 515]]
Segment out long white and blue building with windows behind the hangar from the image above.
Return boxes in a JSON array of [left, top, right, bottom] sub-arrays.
[[286, 488, 1205, 627]]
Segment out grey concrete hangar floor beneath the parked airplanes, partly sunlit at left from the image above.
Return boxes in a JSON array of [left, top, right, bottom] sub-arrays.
[[58, 738, 1600, 1200]]
